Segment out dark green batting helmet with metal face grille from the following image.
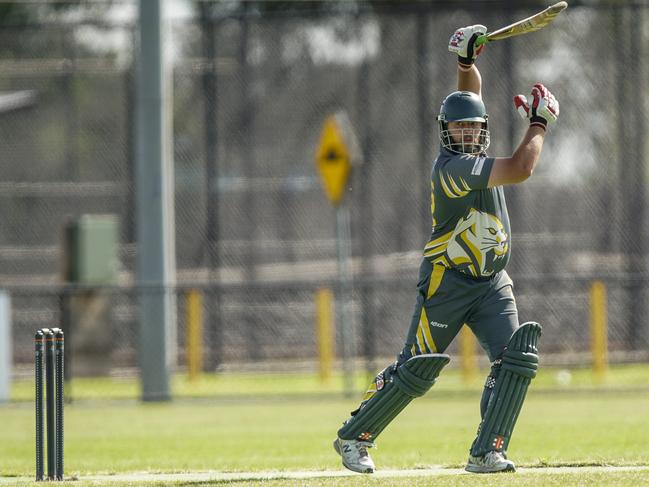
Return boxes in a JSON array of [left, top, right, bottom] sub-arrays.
[[437, 91, 489, 154]]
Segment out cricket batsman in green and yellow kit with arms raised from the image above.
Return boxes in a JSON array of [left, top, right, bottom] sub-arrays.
[[334, 25, 559, 473]]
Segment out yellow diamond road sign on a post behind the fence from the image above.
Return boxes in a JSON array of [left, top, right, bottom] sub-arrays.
[[316, 115, 351, 205]]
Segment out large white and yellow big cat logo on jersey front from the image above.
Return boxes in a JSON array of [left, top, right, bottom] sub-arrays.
[[446, 208, 509, 276]]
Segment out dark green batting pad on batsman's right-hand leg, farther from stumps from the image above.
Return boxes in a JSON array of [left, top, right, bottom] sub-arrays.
[[471, 321, 541, 457]]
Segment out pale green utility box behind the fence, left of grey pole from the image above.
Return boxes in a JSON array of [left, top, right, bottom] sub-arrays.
[[64, 215, 118, 285]]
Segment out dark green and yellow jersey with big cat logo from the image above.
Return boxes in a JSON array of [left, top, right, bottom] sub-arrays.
[[424, 149, 510, 277]]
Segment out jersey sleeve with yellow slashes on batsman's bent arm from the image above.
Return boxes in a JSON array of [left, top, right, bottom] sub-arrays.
[[435, 154, 495, 198]]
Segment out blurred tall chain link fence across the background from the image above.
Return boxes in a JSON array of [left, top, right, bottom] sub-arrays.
[[0, 1, 649, 386]]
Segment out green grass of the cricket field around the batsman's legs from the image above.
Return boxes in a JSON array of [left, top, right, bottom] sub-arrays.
[[0, 366, 649, 486]]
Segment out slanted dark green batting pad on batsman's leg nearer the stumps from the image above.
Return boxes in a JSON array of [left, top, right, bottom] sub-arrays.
[[338, 353, 450, 441]]
